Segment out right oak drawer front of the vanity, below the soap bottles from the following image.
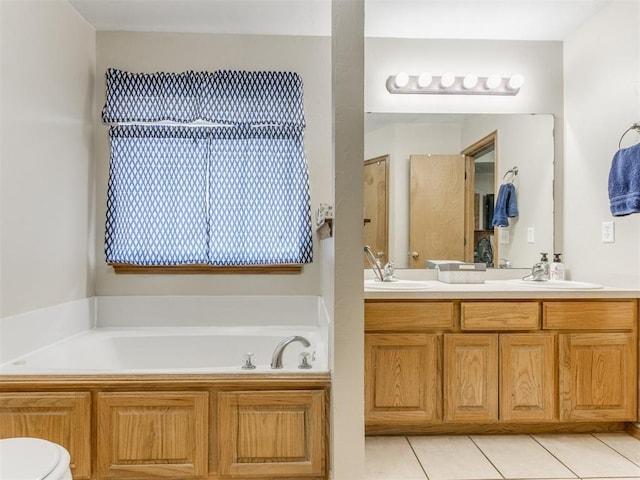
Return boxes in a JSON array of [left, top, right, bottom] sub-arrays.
[[542, 300, 637, 330]]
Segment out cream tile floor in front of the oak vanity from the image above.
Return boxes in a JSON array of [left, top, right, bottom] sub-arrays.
[[365, 433, 640, 480]]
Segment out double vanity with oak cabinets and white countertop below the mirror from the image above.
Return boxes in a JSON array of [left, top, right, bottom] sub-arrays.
[[365, 272, 639, 435]]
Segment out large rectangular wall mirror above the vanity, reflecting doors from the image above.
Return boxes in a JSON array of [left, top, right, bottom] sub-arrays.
[[364, 113, 554, 268]]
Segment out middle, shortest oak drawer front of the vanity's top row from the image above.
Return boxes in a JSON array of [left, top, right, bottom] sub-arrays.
[[460, 302, 540, 331]]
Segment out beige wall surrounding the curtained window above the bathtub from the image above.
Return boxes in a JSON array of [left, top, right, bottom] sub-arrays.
[[95, 31, 333, 295]]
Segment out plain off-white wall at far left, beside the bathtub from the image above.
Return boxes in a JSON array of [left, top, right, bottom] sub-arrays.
[[0, 0, 95, 317]]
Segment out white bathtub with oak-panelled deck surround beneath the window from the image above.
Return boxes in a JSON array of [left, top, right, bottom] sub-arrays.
[[0, 296, 331, 480]]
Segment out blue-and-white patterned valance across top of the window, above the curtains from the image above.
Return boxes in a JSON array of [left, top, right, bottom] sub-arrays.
[[102, 68, 305, 127]]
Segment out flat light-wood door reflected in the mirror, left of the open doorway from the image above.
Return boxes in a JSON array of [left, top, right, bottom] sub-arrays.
[[409, 155, 473, 268]]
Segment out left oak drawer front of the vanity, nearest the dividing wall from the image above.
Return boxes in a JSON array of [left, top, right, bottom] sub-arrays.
[[364, 301, 454, 331]]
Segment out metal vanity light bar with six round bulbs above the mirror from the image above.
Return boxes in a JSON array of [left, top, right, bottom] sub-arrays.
[[387, 72, 524, 95]]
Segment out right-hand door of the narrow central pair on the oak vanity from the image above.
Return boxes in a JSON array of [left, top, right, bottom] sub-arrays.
[[500, 333, 556, 422]]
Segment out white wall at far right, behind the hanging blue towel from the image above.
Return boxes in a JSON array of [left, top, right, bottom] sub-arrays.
[[562, 1, 640, 288]]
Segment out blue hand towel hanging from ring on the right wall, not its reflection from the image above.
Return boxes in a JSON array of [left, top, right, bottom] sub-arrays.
[[609, 144, 640, 217]]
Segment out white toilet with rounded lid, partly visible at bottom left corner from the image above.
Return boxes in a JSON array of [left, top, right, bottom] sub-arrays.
[[0, 437, 72, 480]]
